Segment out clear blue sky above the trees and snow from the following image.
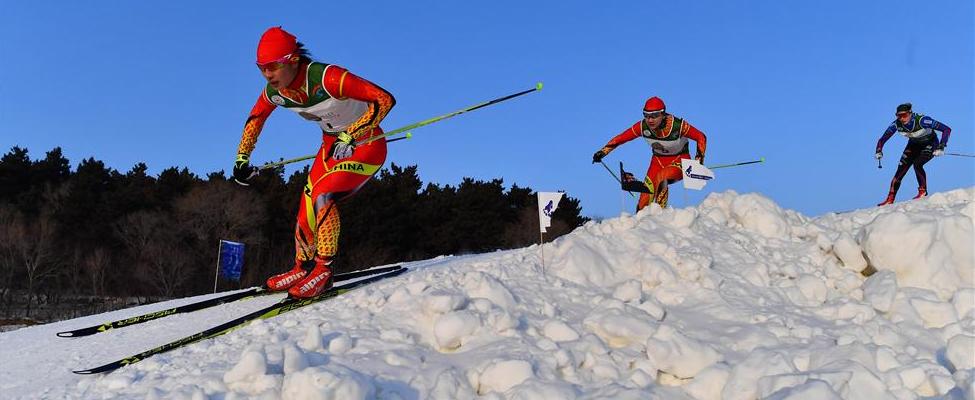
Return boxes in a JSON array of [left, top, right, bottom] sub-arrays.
[[0, 1, 975, 217]]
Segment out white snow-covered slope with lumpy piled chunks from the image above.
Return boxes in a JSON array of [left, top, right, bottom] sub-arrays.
[[0, 188, 975, 400]]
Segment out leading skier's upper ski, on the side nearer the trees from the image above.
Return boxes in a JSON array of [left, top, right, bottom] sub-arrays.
[[57, 265, 402, 337]]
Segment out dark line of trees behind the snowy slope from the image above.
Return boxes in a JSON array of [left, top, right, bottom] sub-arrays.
[[0, 146, 589, 318]]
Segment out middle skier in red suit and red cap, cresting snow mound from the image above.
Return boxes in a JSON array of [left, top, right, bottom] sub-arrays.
[[592, 96, 707, 211]]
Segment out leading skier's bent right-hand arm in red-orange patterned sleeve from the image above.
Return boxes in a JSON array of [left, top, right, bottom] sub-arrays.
[[322, 65, 396, 139]]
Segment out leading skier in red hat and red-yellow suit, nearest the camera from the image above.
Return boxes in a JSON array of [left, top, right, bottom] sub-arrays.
[[234, 27, 395, 297]]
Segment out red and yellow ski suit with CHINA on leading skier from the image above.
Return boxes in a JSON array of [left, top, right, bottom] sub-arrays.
[[238, 61, 395, 261]]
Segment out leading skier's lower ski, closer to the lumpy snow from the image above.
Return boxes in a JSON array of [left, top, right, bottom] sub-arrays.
[[72, 268, 408, 375]]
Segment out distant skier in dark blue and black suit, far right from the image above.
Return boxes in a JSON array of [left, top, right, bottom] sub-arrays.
[[875, 103, 951, 206]]
